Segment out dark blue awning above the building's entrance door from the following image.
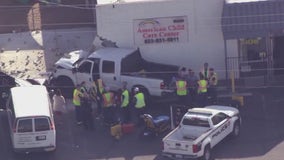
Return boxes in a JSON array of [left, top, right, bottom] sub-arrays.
[[222, 0, 284, 39]]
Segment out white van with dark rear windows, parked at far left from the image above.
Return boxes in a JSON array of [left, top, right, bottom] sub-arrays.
[[6, 85, 56, 152]]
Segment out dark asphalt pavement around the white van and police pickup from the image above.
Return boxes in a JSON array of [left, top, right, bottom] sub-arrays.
[[0, 86, 284, 160]]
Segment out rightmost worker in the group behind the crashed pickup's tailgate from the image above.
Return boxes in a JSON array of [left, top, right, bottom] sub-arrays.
[[208, 68, 218, 104]]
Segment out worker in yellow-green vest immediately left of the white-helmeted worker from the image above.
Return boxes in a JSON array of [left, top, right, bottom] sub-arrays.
[[121, 82, 130, 123]]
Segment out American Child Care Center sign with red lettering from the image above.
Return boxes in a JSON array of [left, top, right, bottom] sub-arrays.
[[133, 16, 188, 45]]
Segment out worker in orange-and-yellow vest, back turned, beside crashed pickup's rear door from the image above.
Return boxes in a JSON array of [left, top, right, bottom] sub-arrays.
[[102, 87, 115, 125]]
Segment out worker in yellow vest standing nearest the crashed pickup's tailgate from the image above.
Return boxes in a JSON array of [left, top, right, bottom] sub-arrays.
[[176, 78, 188, 105]]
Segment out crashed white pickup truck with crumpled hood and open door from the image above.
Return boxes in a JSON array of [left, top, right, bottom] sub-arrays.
[[49, 47, 178, 97]]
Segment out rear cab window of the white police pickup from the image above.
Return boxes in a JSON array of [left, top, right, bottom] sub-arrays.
[[182, 116, 210, 127]]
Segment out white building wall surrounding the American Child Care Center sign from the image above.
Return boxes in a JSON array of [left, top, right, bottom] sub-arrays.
[[96, 0, 237, 78]]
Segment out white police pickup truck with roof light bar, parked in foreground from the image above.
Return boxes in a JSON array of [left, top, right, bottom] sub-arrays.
[[162, 105, 241, 160]]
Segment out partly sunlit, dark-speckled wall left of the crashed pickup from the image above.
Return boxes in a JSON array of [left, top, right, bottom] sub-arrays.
[[0, 28, 96, 78]]
